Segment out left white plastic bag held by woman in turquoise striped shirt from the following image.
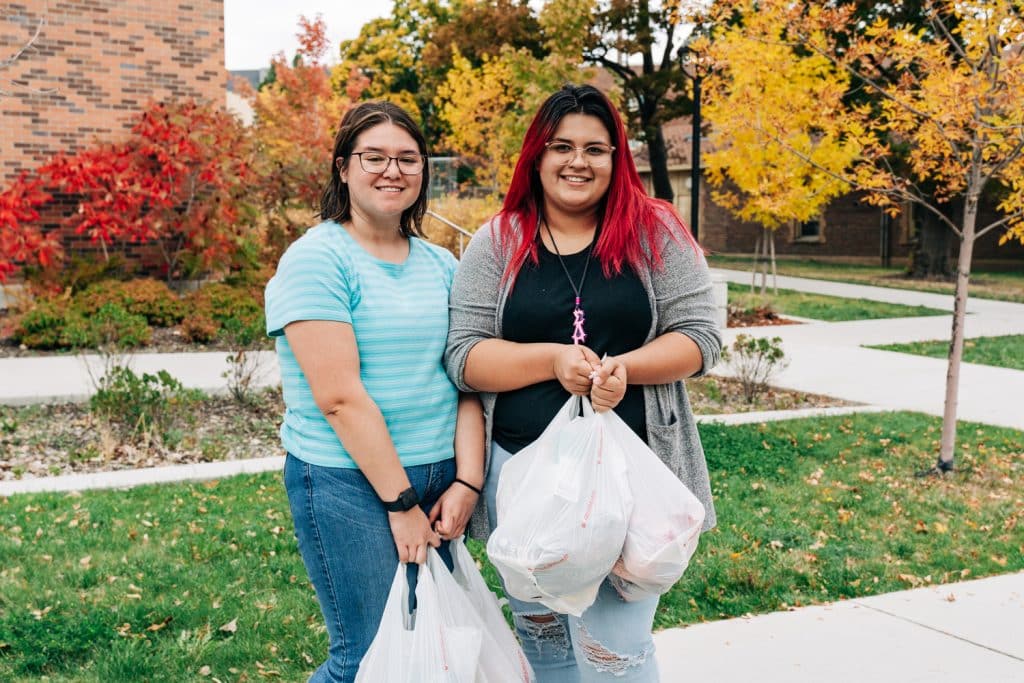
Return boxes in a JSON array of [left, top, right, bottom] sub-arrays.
[[355, 564, 482, 683]]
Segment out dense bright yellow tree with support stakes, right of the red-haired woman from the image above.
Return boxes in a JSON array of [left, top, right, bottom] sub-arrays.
[[692, 7, 858, 293]]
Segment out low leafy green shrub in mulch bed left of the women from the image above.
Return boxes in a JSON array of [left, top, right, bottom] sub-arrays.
[[89, 365, 203, 438]]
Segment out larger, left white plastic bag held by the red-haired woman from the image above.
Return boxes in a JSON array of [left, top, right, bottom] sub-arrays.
[[487, 396, 633, 616]]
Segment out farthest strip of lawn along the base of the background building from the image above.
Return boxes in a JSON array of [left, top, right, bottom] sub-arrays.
[[708, 254, 1024, 303]]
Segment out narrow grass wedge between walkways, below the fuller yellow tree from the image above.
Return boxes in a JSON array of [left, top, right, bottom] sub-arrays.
[[729, 283, 947, 323]]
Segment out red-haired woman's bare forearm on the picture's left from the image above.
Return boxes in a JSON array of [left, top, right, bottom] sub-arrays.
[[464, 339, 564, 392]]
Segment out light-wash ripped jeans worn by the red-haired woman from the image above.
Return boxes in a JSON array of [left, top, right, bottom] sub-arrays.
[[483, 441, 658, 683]]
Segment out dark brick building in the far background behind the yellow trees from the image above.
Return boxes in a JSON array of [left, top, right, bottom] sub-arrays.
[[636, 119, 1024, 267]]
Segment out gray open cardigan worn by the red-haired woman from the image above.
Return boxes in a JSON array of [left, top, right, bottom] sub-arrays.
[[444, 221, 722, 540]]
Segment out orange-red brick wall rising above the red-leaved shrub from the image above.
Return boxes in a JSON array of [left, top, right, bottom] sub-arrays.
[[0, 0, 227, 183]]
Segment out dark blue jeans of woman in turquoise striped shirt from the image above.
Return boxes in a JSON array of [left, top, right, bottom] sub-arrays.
[[285, 454, 455, 683]]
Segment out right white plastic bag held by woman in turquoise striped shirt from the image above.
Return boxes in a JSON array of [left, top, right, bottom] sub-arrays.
[[427, 537, 534, 683]]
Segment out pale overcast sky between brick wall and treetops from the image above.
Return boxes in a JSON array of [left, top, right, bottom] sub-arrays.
[[224, 0, 391, 71]]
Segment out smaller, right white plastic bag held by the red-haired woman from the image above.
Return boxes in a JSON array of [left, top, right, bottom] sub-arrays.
[[601, 411, 705, 600]]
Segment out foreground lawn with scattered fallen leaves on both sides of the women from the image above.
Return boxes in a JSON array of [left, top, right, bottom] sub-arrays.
[[0, 413, 1024, 681]]
